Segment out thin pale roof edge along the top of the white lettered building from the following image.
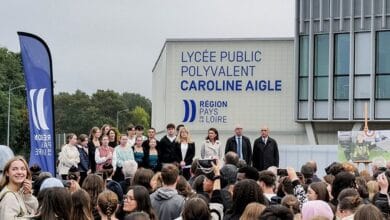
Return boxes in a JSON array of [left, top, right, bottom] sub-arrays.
[[152, 37, 294, 72]]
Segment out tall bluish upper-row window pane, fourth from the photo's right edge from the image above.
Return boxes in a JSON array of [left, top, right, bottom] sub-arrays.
[[314, 34, 329, 76]]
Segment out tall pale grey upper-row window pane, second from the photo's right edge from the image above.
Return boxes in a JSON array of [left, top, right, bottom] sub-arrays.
[[355, 33, 371, 75]]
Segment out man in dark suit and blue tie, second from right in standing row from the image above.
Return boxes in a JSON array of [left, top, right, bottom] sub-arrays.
[[225, 125, 252, 166]]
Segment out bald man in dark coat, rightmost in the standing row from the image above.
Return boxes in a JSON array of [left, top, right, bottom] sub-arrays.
[[252, 126, 279, 171]]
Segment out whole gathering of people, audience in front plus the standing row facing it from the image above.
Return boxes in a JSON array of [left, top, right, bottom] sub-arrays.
[[0, 124, 390, 220]]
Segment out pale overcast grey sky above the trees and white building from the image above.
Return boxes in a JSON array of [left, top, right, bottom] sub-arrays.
[[0, 0, 295, 98]]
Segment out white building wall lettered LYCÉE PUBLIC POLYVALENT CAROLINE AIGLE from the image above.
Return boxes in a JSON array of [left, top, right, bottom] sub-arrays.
[[152, 39, 310, 152]]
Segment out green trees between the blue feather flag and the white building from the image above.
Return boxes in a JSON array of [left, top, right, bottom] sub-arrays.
[[55, 90, 151, 134]]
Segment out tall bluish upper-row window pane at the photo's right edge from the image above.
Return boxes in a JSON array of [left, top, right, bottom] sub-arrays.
[[376, 31, 390, 74]]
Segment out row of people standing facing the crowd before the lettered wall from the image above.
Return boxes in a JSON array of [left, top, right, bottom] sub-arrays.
[[58, 123, 279, 182]]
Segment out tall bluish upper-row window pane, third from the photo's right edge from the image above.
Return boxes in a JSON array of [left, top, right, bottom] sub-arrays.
[[334, 34, 350, 75]]
